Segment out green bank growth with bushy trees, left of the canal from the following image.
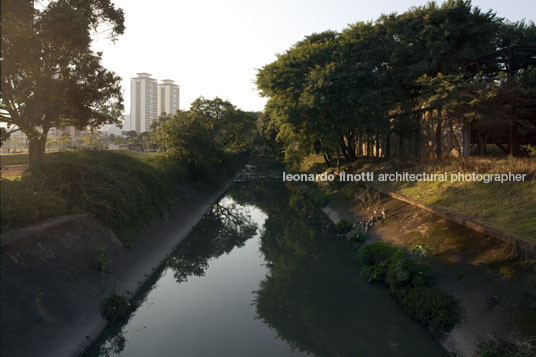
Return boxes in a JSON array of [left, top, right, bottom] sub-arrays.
[[1, 98, 256, 241]]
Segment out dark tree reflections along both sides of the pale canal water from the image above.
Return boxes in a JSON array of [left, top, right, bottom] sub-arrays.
[[88, 171, 445, 356]]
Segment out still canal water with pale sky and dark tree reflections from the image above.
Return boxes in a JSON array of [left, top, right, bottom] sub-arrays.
[[85, 161, 446, 357]]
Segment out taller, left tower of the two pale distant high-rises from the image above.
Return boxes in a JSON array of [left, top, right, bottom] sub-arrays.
[[130, 73, 157, 134]]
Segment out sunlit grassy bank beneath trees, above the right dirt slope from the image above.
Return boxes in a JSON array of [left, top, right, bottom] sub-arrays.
[[300, 157, 536, 243]]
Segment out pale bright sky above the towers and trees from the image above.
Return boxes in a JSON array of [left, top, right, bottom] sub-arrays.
[[94, 0, 536, 114]]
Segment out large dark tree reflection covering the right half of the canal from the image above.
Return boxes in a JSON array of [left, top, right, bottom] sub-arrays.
[[233, 183, 446, 356]]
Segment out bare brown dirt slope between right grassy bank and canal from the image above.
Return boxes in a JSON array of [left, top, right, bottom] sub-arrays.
[[324, 189, 536, 357]]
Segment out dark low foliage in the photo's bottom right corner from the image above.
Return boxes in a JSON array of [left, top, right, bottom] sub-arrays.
[[475, 336, 536, 357]]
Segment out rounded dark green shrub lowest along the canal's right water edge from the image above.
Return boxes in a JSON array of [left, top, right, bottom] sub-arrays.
[[394, 286, 460, 333]]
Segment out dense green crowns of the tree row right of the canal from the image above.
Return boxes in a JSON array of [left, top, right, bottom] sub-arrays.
[[257, 0, 536, 163]]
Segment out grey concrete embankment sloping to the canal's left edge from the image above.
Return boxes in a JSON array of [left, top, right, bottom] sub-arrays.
[[0, 179, 232, 357]]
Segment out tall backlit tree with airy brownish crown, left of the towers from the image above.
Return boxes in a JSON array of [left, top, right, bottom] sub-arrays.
[[0, 0, 125, 166]]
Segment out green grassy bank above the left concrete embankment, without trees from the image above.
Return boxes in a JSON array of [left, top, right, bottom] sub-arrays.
[[0, 151, 242, 241]]
